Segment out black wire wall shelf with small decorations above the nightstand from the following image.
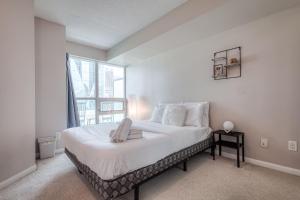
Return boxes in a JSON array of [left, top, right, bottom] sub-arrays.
[[212, 47, 242, 80]]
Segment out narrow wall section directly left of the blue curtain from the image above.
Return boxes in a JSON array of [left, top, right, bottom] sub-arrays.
[[35, 18, 67, 148]]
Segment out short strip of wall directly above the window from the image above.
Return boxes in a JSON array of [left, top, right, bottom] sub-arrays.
[[66, 41, 107, 61]]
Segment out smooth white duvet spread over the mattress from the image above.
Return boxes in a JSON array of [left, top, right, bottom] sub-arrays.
[[62, 121, 211, 180]]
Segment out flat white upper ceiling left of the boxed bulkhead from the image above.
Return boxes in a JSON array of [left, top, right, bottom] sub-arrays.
[[34, 0, 187, 49]]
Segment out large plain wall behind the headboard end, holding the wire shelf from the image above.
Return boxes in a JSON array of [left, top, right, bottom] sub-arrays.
[[127, 7, 300, 169]]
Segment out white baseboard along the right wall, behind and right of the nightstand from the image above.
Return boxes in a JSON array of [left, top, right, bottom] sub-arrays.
[[216, 150, 300, 176]]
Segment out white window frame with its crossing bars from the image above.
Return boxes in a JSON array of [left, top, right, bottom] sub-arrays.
[[70, 54, 127, 126]]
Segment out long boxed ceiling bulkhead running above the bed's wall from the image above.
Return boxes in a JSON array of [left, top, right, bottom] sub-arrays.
[[107, 0, 300, 62]]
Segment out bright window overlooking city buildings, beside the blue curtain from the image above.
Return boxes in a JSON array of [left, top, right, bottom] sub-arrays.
[[70, 56, 126, 126]]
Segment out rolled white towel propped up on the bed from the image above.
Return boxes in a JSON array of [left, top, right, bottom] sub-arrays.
[[109, 118, 132, 143]]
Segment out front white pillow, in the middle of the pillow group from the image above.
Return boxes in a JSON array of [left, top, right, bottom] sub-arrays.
[[162, 104, 186, 126]]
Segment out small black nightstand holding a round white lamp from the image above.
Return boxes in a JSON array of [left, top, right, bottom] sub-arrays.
[[213, 130, 245, 167]]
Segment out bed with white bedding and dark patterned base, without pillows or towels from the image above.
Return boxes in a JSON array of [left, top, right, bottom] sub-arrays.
[[62, 121, 214, 200]]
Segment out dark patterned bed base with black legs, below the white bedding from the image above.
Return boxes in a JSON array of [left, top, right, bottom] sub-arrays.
[[65, 137, 215, 200]]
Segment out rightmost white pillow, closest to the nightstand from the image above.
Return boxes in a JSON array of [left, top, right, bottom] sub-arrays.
[[184, 102, 209, 127]]
